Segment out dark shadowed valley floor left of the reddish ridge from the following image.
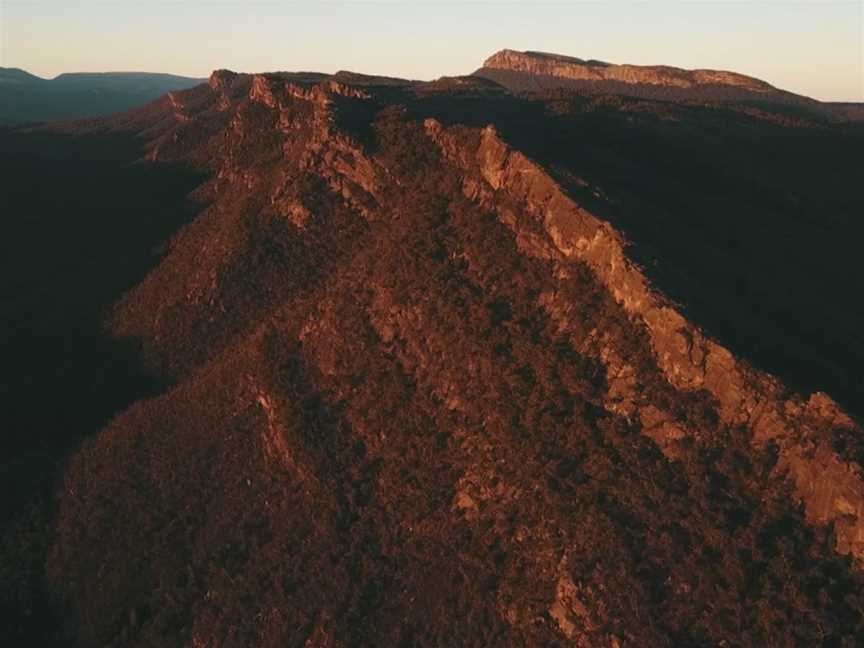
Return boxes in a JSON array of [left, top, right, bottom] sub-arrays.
[[0, 126, 202, 645]]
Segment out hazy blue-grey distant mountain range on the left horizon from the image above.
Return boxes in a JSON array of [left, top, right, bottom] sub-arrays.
[[0, 68, 204, 124]]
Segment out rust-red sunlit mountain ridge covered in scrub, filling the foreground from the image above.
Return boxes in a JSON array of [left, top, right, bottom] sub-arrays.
[[6, 52, 864, 648]]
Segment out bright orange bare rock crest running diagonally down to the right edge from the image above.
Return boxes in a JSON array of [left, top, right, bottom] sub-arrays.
[[426, 120, 864, 564]]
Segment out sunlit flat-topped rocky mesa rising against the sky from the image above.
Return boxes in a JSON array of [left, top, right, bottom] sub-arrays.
[[483, 49, 777, 93]]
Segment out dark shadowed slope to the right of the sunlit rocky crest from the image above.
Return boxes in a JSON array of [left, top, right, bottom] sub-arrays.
[[411, 96, 864, 419]]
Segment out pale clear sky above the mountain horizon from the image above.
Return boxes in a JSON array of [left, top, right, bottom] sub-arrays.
[[0, 0, 864, 101]]
